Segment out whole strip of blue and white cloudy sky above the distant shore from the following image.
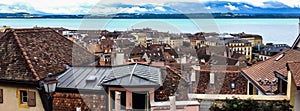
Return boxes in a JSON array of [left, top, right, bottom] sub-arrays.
[[0, 0, 300, 14]]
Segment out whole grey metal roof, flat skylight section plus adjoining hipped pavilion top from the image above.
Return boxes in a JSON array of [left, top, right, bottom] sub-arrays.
[[57, 64, 162, 90]]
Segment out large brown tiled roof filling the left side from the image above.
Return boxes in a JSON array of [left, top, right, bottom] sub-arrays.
[[0, 28, 95, 81]]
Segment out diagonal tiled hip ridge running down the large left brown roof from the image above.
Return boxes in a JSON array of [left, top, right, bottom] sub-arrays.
[[11, 30, 40, 81]]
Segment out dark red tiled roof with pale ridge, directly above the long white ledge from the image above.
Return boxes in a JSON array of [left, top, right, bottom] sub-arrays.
[[193, 65, 248, 94]]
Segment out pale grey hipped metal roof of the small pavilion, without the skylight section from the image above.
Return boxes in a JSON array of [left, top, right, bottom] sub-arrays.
[[102, 64, 162, 86]]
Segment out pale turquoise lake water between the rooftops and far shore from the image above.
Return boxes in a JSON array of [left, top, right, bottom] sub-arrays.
[[0, 19, 298, 45]]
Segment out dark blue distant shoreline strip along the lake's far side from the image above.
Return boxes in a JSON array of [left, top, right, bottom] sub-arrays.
[[0, 13, 300, 19]]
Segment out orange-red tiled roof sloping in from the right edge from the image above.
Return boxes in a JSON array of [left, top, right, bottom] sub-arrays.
[[242, 50, 300, 92]]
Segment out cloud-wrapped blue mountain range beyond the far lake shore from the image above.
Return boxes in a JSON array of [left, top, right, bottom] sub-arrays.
[[0, 1, 300, 15]]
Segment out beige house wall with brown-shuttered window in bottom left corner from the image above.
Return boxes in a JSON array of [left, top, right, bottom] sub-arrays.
[[0, 83, 44, 111]]
